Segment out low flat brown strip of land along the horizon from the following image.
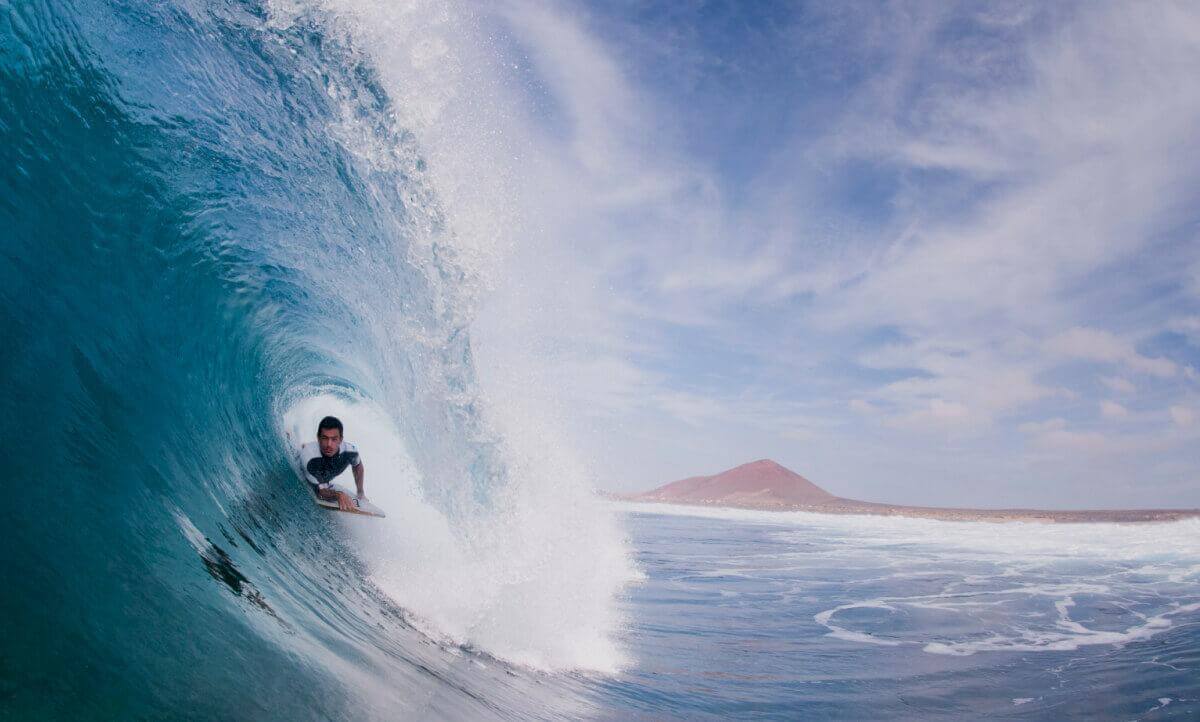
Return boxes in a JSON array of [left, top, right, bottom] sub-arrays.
[[619, 494, 1200, 524]]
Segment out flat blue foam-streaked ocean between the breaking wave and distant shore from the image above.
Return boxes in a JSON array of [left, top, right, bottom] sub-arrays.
[[600, 504, 1200, 720]]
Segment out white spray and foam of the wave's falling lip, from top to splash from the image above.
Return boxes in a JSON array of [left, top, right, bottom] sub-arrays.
[[259, 0, 638, 670]]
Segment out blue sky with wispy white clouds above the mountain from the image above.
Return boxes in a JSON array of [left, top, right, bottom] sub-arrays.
[[451, 0, 1200, 509]]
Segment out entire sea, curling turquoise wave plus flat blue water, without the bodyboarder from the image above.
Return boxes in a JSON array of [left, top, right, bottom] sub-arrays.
[[0, 0, 1200, 720]]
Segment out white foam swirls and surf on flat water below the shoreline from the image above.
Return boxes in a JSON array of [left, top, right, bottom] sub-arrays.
[[614, 503, 1200, 656]]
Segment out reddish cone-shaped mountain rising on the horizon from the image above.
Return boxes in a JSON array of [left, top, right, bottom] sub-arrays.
[[635, 459, 839, 506]]
